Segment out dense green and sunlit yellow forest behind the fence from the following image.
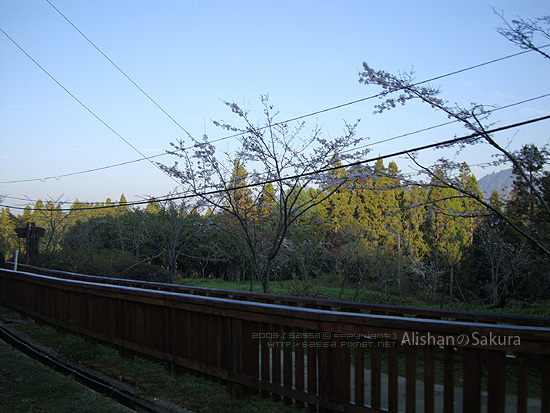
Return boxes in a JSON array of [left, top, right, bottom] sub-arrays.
[[0, 145, 550, 307]]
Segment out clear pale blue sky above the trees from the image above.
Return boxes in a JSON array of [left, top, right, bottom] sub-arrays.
[[0, 0, 550, 213]]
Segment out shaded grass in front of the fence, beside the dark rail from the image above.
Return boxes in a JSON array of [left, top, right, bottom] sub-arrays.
[[0, 307, 295, 413]]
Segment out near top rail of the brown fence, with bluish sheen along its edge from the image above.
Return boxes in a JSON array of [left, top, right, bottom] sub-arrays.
[[4, 270, 550, 354]]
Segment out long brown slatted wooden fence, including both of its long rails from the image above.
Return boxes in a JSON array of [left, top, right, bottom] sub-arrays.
[[0, 268, 550, 412]]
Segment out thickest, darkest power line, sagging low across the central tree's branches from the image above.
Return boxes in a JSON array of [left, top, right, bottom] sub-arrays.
[[0, 115, 550, 212]]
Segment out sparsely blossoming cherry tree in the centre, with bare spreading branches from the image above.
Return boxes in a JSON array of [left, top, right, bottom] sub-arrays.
[[162, 96, 367, 293]]
